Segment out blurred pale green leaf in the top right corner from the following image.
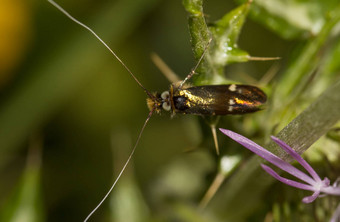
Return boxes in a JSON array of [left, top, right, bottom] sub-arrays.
[[239, 0, 339, 39]]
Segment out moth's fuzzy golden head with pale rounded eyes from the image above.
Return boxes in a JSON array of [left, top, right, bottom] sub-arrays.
[[146, 91, 171, 113]]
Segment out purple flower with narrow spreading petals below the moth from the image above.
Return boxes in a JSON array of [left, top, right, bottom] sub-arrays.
[[220, 128, 340, 203]]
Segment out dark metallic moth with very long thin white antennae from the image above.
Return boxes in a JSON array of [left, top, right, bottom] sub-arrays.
[[48, 0, 267, 221]]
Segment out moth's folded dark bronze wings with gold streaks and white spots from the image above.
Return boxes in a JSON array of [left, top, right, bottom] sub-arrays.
[[172, 84, 267, 115]]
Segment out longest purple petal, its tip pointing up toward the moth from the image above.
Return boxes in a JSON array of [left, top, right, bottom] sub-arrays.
[[220, 128, 316, 185]]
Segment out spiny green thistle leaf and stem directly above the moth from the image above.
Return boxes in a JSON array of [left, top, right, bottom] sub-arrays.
[[183, 0, 254, 85]]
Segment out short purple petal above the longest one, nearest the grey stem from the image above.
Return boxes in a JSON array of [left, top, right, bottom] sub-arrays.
[[271, 136, 321, 182]]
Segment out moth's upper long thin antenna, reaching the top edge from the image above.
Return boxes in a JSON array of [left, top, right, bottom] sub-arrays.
[[47, 0, 155, 99]]
